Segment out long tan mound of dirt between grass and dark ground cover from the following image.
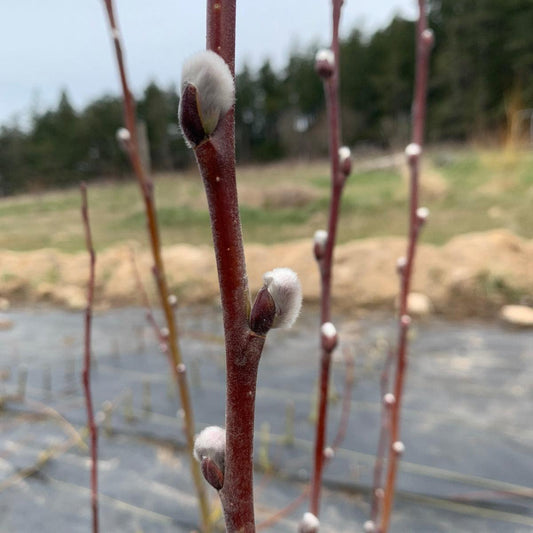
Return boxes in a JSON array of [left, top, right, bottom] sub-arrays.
[[0, 230, 533, 317]]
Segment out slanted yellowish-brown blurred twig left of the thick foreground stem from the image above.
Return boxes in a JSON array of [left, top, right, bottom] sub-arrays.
[[100, 0, 211, 531]]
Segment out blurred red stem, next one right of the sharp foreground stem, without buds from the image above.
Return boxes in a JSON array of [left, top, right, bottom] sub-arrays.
[[310, 0, 344, 517]]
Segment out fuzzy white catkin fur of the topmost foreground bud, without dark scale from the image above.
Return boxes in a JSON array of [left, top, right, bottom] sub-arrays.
[[181, 50, 235, 135]]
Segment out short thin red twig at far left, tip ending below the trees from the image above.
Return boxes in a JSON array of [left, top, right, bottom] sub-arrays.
[[80, 183, 99, 533]]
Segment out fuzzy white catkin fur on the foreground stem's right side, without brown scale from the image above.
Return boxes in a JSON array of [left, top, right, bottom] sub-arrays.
[[263, 268, 302, 328]]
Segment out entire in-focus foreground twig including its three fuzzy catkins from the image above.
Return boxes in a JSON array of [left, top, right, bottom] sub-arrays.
[[179, 0, 301, 533]]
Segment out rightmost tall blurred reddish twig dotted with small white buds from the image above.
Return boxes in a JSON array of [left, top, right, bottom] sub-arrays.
[[379, 0, 433, 533]]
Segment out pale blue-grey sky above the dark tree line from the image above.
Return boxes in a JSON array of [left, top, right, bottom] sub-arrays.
[[0, 0, 417, 126]]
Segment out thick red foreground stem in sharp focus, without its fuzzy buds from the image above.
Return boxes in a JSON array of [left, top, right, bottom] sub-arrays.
[[195, 0, 265, 533]]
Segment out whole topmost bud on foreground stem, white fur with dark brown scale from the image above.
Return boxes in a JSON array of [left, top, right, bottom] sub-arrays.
[[178, 50, 235, 147]]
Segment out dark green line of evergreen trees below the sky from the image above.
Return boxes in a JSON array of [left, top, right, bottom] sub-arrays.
[[0, 0, 533, 195]]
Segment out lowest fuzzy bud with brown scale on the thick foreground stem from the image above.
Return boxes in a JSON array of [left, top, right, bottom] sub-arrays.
[[194, 426, 226, 490]]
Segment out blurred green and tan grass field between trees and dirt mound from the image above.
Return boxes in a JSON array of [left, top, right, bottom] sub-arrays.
[[0, 149, 533, 252]]
